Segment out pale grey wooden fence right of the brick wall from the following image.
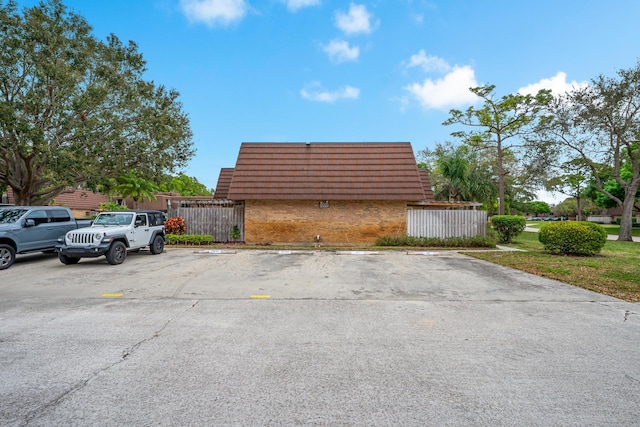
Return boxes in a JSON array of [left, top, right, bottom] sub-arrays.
[[407, 209, 487, 239]]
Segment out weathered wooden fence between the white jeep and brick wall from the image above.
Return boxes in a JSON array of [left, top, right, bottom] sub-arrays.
[[168, 205, 244, 242]]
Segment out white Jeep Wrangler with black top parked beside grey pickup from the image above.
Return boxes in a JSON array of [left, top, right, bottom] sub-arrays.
[[55, 210, 165, 265]]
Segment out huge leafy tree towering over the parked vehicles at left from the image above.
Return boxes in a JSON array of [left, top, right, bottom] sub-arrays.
[[0, 0, 194, 205]]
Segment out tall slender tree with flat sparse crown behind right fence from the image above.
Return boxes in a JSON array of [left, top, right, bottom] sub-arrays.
[[443, 85, 552, 215]]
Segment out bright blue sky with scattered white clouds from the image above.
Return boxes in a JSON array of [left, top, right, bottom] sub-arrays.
[[12, 0, 640, 201]]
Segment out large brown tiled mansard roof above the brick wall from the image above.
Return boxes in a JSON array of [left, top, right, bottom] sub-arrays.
[[222, 142, 432, 201]]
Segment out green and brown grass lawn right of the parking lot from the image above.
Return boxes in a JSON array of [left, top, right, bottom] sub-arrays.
[[467, 230, 640, 302]]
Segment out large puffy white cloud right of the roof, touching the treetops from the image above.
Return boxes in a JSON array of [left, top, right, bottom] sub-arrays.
[[405, 65, 478, 109]]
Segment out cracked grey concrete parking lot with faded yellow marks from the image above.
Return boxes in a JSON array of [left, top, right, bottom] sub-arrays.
[[0, 248, 640, 426]]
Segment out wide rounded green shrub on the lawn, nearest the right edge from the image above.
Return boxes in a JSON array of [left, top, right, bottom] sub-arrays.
[[538, 221, 607, 256]]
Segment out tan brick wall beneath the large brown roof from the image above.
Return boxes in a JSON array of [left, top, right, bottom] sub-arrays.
[[244, 200, 407, 245]]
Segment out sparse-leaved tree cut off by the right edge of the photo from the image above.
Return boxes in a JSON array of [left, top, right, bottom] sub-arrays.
[[541, 62, 640, 241]]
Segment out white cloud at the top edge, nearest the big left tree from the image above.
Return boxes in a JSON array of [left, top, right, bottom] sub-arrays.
[[180, 0, 249, 27]]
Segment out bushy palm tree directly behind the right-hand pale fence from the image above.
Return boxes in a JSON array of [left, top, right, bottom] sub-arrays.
[[420, 143, 497, 205]]
